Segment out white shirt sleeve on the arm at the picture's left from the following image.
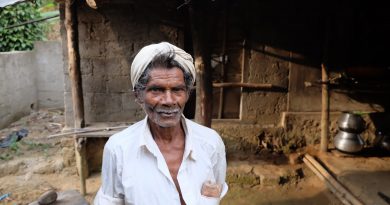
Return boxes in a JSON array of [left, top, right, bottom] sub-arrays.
[[94, 144, 124, 205]]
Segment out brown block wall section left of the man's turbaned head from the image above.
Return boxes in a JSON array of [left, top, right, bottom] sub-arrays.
[[60, 1, 183, 127]]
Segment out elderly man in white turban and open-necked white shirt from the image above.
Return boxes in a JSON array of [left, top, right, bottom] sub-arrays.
[[94, 42, 227, 205]]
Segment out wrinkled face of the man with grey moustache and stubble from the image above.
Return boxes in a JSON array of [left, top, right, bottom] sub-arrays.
[[138, 67, 188, 127]]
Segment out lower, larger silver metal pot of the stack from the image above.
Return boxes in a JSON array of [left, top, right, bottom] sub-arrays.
[[334, 130, 364, 153]]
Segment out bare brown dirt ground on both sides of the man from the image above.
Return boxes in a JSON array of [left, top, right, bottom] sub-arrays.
[[0, 109, 340, 205]]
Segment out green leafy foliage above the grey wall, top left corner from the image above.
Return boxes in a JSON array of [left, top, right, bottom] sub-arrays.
[[0, 1, 44, 52]]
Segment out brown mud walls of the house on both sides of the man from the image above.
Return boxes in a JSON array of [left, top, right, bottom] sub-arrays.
[[61, 0, 386, 152]]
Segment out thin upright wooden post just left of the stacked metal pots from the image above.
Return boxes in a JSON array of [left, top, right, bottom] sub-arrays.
[[320, 64, 329, 152]]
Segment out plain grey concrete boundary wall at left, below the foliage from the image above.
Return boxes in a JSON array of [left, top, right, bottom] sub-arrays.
[[0, 41, 64, 128]]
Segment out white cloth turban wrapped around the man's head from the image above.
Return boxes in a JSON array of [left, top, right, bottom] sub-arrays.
[[130, 42, 196, 90]]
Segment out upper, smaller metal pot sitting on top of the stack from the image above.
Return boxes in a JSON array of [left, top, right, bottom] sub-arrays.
[[338, 112, 365, 133]]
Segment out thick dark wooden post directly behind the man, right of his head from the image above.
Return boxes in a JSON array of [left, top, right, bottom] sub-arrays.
[[189, 6, 213, 127]]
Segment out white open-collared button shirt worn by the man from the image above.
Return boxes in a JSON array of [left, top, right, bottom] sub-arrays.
[[94, 117, 228, 205]]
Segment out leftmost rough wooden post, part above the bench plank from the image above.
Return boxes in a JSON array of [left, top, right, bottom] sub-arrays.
[[65, 0, 85, 128]]
